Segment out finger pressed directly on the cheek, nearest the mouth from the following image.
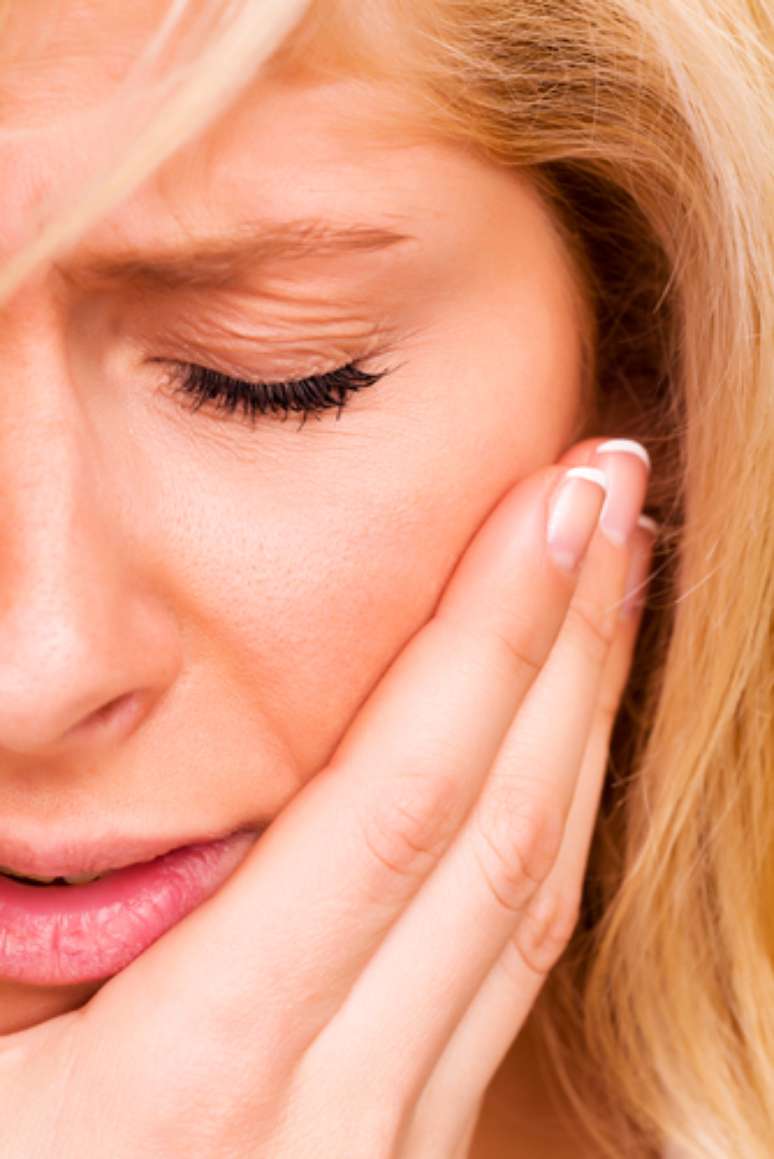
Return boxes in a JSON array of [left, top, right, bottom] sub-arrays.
[[92, 454, 603, 1063]]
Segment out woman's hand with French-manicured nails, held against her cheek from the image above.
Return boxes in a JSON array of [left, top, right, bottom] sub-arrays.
[[0, 440, 651, 1159]]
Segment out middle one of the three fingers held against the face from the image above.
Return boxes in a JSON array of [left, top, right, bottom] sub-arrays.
[[305, 442, 647, 1092]]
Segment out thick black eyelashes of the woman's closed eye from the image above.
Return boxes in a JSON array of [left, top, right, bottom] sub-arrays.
[[168, 360, 389, 427]]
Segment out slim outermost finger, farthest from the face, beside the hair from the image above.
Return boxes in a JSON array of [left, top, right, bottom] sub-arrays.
[[407, 517, 655, 1154]]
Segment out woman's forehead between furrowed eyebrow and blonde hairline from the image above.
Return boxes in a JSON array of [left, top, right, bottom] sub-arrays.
[[0, 0, 574, 343]]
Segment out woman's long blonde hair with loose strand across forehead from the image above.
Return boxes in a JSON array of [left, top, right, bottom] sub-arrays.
[[0, 0, 774, 1159]]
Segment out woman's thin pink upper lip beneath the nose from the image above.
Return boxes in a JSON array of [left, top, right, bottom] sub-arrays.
[[0, 825, 261, 877]]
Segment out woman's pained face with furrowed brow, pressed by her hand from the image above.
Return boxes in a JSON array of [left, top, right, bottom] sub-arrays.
[[0, 3, 581, 1030]]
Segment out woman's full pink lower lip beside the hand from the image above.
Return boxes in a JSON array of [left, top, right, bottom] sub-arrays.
[[0, 831, 257, 986]]
